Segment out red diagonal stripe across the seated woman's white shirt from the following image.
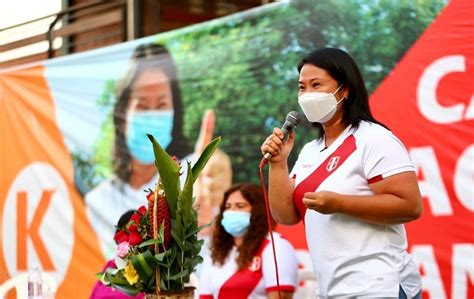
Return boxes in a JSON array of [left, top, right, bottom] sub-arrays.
[[218, 239, 269, 299]]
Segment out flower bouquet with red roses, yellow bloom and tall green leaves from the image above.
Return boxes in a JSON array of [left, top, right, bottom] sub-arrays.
[[98, 135, 220, 298]]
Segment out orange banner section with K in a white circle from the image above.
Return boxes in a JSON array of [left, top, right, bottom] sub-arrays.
[[0, 66, 104, 298]]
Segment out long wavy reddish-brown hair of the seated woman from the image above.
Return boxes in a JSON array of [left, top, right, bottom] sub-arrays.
[[211, 183, 276, 269]]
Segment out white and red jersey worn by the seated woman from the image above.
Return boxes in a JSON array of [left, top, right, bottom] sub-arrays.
[[199, 233, 298, 299]]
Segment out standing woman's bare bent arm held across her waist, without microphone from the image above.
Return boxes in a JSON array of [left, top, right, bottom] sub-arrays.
[[303, 171, 423, 224]]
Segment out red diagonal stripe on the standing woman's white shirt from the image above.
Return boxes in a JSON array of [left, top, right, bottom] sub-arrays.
[[293, 135, 357, 220]]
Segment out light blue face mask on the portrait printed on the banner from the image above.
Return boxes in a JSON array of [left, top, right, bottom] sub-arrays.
[[126, 110, 174, 164]]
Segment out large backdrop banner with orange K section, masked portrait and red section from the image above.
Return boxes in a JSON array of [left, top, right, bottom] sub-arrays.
[[0, 0, 474, 298]]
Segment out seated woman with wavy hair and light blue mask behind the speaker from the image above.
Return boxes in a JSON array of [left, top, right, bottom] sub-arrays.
[[199, 184, 298, 299]]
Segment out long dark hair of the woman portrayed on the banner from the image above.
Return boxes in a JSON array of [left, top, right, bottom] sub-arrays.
[[113, 44, 191, 182]]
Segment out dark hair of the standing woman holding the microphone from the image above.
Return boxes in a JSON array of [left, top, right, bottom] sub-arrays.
[[298, 48, 386, 138]]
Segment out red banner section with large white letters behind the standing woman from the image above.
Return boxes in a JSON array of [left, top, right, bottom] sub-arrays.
[[371, 0, 474, 299]]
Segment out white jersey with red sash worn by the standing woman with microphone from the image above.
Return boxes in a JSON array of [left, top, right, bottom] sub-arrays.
[[290, 121, 421, 298]]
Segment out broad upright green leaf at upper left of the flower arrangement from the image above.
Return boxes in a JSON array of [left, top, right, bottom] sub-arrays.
[[147, 134, 179, 216]]
